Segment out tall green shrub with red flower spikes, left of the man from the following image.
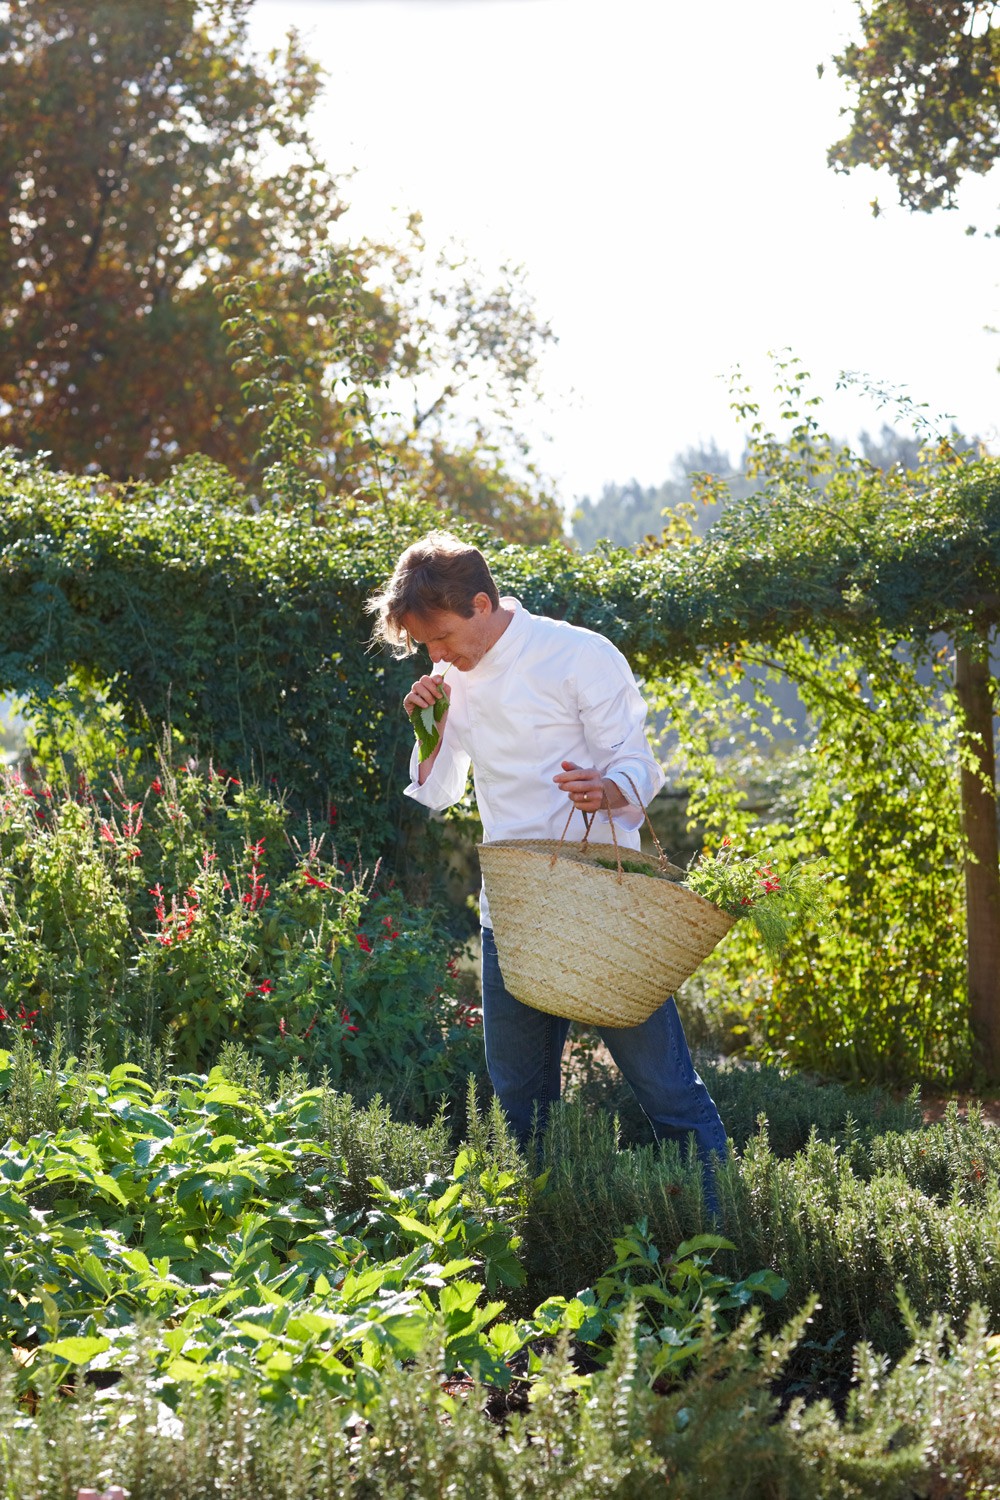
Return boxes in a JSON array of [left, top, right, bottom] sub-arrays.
[[0, 758, 483, 1118]]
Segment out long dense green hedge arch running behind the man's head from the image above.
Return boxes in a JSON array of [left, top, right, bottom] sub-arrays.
[[0, 453, 1000, 1080]]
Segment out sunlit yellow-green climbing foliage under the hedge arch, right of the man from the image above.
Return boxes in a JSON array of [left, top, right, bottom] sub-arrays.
[[661, 644, 972, 1088]]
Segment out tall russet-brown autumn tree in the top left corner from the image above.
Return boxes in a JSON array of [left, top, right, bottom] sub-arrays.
[[0, 0, 343, 477]]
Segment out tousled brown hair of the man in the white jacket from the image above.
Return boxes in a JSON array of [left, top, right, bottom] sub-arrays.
[[364, 531, 499, 657]]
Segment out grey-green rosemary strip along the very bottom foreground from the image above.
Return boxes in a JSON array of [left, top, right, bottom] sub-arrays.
[[0, 1314, 1000, 1500]]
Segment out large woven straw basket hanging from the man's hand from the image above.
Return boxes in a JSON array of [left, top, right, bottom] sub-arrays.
[[478, 830, 735, 1026]]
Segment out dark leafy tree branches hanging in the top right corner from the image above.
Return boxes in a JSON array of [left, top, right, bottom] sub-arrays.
[[829, 0, 1000, 213]]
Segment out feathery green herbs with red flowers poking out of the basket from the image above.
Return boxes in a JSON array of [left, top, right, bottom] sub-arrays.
[[684, 837, 826, 960]]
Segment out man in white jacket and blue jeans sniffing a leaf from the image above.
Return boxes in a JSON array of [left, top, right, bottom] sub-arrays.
[[369, 531, 727, 1187]]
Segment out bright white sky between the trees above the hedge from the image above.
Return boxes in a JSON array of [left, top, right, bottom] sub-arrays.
[[252, 0, 1000, 503]]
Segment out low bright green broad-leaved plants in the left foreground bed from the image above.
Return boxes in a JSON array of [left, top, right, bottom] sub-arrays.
[[0, 1056, 530, 1410]]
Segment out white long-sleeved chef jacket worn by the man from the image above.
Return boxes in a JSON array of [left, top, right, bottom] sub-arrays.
[[406, 599, 664, 927]]
